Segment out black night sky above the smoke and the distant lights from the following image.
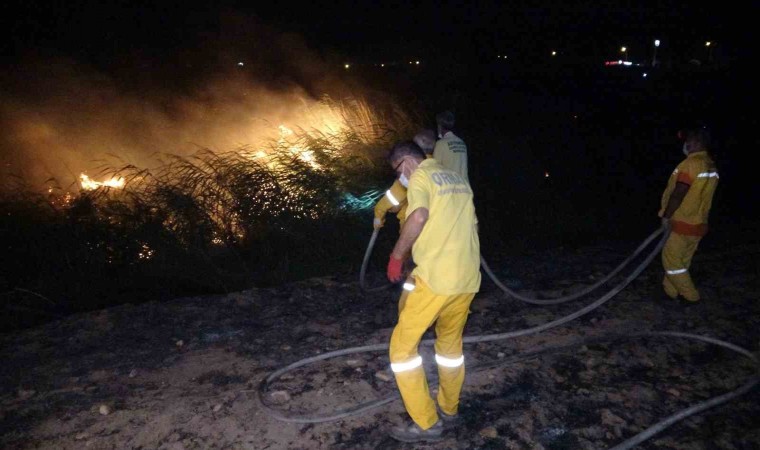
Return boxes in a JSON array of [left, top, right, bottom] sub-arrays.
[[0, 0, 758, 67]]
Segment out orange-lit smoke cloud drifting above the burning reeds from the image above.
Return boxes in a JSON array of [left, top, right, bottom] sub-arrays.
[[0, 13, 362, 189]]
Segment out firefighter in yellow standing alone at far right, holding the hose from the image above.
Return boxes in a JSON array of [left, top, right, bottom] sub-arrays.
[[658, 128, 719, 302]]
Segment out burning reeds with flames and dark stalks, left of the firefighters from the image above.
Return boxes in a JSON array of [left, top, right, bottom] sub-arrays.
[[0, 99, 420, 328]]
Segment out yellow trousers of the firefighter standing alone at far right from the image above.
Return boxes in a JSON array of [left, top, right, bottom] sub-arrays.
[[662, 232, 702, 302]]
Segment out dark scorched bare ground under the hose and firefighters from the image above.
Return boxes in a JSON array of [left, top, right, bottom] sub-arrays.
[[0, 225, 760, 450]]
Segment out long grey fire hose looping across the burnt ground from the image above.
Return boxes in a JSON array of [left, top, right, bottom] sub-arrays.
[[257, 227, 760, 450]]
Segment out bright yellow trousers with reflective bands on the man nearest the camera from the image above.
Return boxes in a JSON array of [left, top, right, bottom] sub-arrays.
[[390, 278, 475, 430]]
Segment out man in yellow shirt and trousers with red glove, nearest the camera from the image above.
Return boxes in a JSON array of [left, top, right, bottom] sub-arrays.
[[388, 142, 481, 442]]
